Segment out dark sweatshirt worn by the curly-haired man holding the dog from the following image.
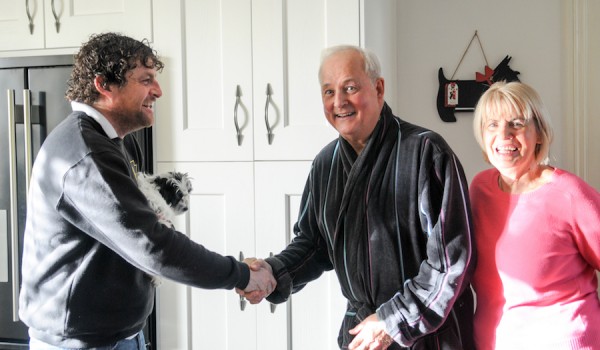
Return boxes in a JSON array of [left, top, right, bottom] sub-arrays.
[[19, 106, 249, 348]]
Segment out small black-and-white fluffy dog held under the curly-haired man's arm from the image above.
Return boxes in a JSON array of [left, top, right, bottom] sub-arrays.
[[137, 171, 192, 286]]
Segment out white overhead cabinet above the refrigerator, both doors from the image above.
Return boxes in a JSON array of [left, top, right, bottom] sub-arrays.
[[0, 0, 152, 51]]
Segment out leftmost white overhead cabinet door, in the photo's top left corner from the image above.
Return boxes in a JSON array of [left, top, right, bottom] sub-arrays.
[[0, 0, 44, 51]]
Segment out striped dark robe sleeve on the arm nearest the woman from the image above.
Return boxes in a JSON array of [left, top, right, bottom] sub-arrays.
[[377, 135, 476, 346]]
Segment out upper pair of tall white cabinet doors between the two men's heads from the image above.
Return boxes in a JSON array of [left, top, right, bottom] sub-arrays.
[[156, 0, 359, 161]]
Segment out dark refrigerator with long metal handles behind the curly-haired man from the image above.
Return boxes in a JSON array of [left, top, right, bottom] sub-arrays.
[[0, 55, 156, 349]]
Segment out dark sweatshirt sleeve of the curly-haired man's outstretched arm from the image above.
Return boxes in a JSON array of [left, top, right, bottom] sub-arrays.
[[57, 148, 250, 289]]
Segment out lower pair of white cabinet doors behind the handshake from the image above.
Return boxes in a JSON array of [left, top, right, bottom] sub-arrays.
[[157, 161, 345, 350]]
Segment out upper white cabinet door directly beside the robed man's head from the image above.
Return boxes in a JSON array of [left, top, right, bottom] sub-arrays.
[[252, 0, 360, 160]]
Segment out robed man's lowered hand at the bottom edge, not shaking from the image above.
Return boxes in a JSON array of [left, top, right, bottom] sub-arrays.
[[348, 314, 394, 350]]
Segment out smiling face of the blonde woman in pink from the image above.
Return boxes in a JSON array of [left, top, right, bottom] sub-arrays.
[[482, 109, 540, 178]]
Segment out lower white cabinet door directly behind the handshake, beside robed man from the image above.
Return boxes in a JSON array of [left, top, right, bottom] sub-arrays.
[[254, 161, 346, 350]]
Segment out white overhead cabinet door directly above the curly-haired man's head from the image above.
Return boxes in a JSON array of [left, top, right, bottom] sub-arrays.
[[44, 0, 153, 48]]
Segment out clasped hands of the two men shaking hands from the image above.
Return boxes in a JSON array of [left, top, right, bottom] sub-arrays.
[[235, 258, 277, 304]]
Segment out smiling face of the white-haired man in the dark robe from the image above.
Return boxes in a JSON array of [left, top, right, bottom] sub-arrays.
[[319, 50, 384, 153]]
